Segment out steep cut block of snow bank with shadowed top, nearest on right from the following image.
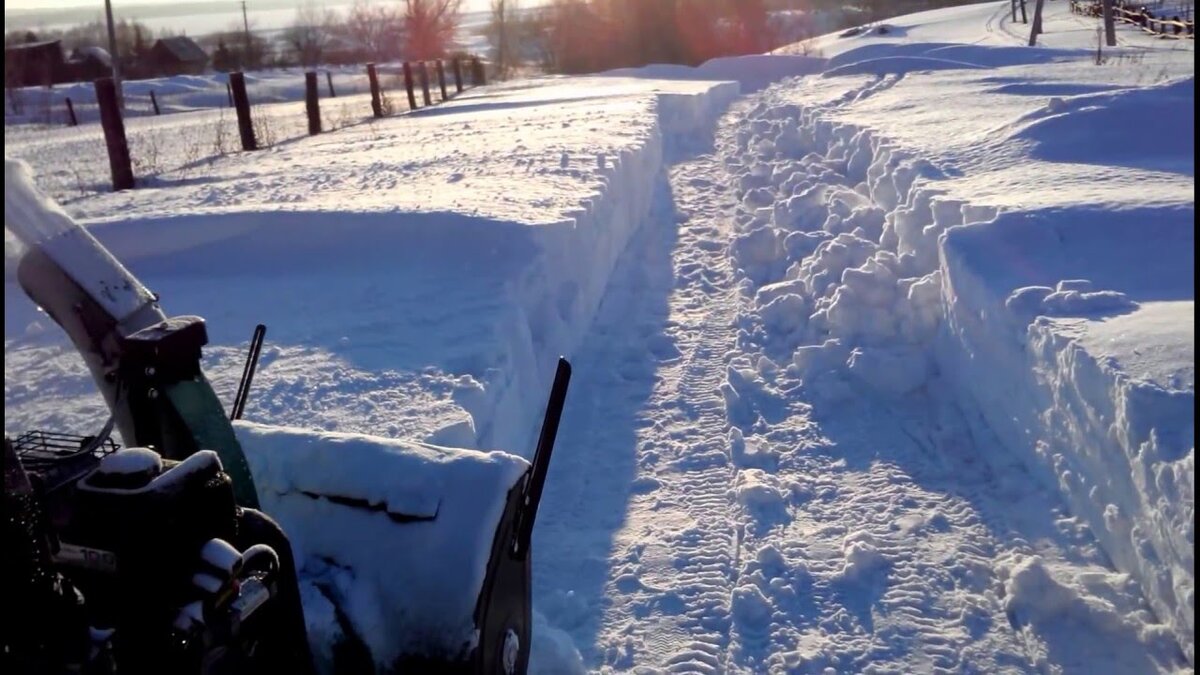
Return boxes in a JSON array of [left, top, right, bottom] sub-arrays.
[[937, 209, 1195, 658]]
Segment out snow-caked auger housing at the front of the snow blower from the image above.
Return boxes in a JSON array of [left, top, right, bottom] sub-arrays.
[[235, 422, 529, 665]]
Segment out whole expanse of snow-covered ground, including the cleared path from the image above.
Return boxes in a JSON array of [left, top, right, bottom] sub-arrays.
[[5, 0, 1195, 674]]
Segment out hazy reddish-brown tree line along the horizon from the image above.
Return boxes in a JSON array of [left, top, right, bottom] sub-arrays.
[[5, 0, 979, 77]]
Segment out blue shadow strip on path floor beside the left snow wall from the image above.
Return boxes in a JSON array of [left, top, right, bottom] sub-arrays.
[[533, 171, 678, 667]]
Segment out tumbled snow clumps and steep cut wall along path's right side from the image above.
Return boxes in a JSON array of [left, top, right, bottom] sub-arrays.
[[727, 90, 1194, 663]]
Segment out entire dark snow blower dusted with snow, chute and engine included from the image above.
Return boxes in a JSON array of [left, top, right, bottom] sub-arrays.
[[2, 161, 570, 674]]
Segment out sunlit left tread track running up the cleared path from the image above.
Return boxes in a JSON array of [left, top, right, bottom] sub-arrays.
[[634, 156, 738, 673]]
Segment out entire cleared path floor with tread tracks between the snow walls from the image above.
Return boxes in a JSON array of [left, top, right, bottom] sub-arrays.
[[535, 82, 1182, 673]]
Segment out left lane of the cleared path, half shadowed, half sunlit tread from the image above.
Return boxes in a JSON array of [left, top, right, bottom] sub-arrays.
[[535, 138, 739, 673]]
